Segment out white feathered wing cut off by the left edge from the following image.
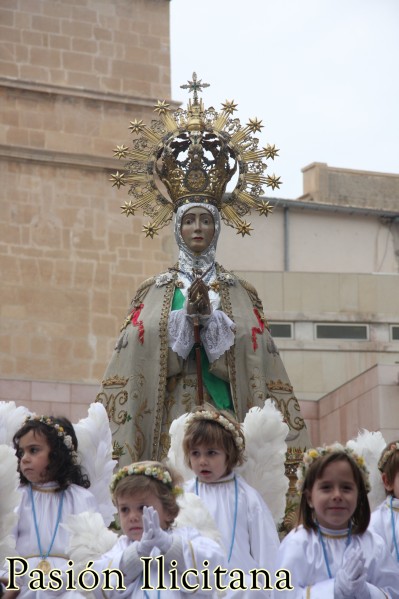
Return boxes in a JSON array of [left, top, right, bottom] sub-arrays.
[[0, 445, 21, 565]]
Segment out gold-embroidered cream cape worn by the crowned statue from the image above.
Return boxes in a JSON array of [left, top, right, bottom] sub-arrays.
[[97, 264, 309, 466]]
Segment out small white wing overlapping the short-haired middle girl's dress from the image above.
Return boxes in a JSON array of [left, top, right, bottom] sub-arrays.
[[175, 493, 222, 545]]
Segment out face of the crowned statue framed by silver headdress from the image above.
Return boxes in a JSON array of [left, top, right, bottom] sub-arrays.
[[181, 206, 215, 254]]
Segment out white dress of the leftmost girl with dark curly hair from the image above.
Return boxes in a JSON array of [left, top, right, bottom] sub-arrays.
[[1, 482, 98, 599]]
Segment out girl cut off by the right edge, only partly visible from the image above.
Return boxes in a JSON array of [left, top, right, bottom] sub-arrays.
[[370, 441, 399, 575]]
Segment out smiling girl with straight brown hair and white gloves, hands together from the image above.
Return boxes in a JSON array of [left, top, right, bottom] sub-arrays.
[[273, 443, 399, 599]]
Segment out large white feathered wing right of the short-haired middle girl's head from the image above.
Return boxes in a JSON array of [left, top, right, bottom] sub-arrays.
[[236, 399, 289, 524]]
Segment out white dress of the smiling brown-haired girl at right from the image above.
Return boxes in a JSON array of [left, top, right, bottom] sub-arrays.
[[273, 526, 399, 599]]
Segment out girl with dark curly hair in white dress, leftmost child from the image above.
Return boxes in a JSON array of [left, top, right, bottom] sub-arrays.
[[2, 416, 98, 599]]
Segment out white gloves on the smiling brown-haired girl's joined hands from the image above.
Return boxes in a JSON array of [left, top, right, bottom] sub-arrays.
[[334, 547, 370, 599]]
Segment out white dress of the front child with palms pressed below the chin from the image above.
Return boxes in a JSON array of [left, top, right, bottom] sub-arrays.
[[94, 527, 226, 599]]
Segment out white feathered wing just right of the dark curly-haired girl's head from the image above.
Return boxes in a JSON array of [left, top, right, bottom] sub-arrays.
[[74, 403, 117, 526]]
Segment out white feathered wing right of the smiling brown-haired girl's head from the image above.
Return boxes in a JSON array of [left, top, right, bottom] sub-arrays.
[[346, 429, 386, 511]]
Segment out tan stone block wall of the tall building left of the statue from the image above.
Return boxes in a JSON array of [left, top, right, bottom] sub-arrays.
[[0, 0, 175, 384]]
